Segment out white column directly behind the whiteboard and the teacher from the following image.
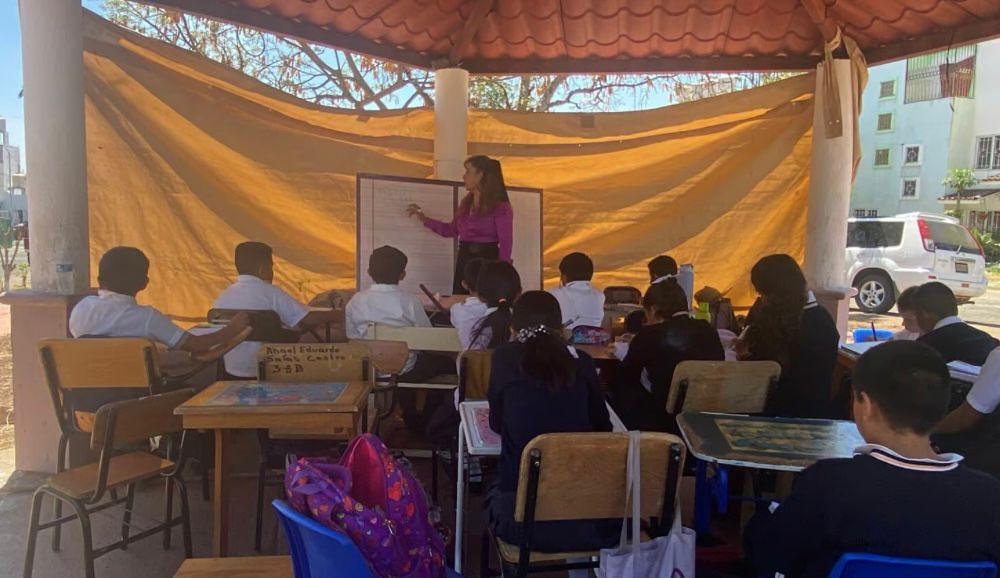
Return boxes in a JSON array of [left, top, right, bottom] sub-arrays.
[[434, 68, 469, 181]]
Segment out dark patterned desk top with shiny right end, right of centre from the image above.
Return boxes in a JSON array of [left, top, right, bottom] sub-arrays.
[[677, 412, 865, 472]]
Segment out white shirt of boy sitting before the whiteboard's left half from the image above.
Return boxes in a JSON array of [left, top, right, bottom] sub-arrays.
[[344, 283, 431, 373]]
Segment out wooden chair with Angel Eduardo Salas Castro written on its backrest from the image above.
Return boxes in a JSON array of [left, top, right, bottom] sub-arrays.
[[254, 343, 374, 552]]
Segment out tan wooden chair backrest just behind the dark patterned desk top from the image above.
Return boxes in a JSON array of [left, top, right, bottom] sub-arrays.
[[666, 361, 781, 414]]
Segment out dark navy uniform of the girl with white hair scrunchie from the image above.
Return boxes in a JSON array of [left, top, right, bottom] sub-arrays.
[[488, 342, 620, 552]]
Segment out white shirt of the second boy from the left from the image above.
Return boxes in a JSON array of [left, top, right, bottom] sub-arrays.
[[212, 275, 309, 378]]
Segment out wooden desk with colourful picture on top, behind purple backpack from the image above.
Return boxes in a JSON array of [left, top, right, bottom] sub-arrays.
[[174, 381, 372, 557]]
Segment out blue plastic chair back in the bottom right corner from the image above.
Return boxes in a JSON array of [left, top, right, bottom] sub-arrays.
[[829, 554, 997, 578]]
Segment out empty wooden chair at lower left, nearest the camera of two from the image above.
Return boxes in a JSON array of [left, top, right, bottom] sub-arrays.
[[24, 389, 194, 578]]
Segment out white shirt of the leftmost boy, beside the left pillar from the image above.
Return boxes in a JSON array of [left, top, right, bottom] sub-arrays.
[[69, 289, 188, 349]]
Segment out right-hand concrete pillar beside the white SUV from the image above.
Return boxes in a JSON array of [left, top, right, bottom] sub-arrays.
[[803, 59, 854, 336]]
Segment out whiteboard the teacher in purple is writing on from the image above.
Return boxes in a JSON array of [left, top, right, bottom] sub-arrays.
[[357, 174, 543, 295]]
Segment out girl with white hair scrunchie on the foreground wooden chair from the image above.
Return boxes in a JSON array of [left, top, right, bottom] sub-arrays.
[[487, 291, 620, 552]]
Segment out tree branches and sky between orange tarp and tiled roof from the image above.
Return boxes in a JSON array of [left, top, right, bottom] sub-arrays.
[[104, 0, 791, 112]]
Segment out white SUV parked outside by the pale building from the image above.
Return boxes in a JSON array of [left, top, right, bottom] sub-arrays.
[[846, 213, 987, 313]]
